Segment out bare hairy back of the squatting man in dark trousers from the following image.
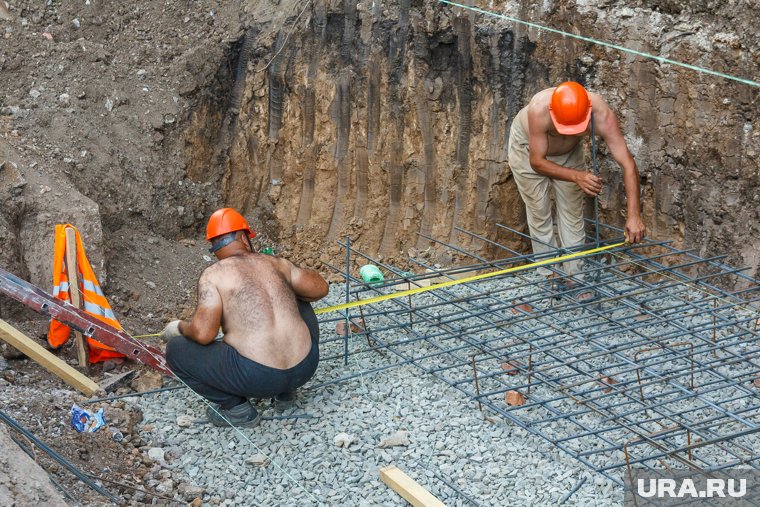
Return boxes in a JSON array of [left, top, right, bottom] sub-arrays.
[[199, 253, 311, 369]]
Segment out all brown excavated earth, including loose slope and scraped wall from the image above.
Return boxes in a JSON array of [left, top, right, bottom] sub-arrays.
[[0, 0, 760, 503]]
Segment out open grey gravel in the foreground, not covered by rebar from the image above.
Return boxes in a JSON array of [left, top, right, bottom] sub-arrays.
[[128, 285, 622, 506]]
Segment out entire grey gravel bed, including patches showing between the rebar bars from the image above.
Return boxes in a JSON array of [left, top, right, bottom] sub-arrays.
[[131, 274, 757, 506]]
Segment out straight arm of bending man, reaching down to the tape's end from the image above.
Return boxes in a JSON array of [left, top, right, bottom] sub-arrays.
[[594, 104, 647, 243]]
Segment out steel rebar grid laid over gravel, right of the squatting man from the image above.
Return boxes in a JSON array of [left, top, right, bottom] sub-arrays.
[[315, 224, 760, 484]]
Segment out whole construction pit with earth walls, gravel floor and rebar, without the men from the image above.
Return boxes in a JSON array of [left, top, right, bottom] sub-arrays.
[[0, 0, 760, 506]]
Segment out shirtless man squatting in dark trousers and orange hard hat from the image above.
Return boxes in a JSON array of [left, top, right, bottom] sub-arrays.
[[161, 208, 328, 427]]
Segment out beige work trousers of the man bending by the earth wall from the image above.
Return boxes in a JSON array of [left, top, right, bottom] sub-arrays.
[[509, 110, 586, 278]]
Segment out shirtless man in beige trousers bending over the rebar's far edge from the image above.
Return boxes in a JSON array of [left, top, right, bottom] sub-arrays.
[[509, 81, 646, 284]]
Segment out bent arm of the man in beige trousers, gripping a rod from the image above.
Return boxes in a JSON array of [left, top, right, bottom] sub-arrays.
[[528, 108, 602, 195]]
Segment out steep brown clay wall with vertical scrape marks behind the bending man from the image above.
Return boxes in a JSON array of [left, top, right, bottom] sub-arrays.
[[181, 1, 760, 272]]
